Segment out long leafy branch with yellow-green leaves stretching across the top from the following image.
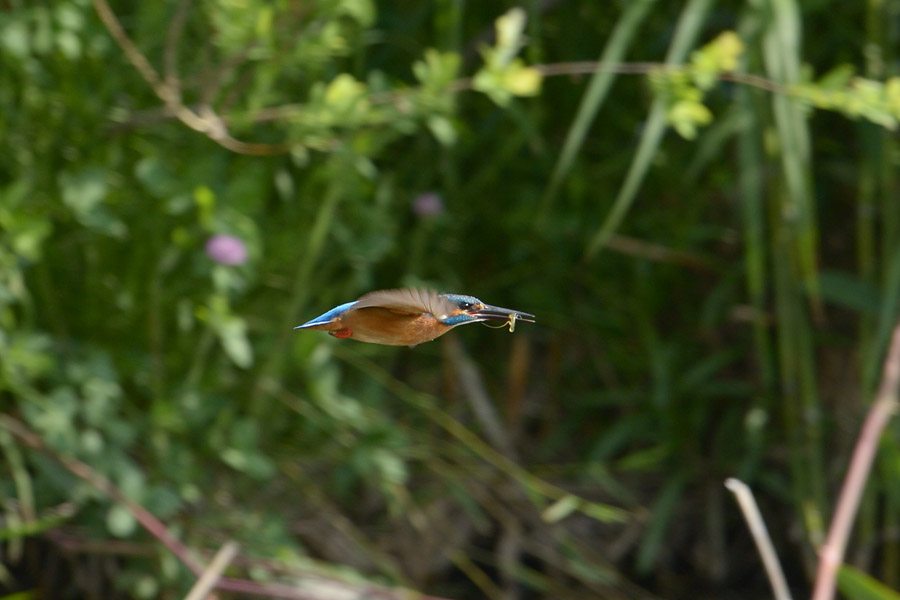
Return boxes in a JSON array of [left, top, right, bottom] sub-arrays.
[[93, 0, 900, 155]]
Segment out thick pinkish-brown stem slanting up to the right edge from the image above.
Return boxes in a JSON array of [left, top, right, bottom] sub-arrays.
[[812, 323, 900, 600]]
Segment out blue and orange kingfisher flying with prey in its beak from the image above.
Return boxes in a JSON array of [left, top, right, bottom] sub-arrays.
[[294, 289, 534, 346]]
